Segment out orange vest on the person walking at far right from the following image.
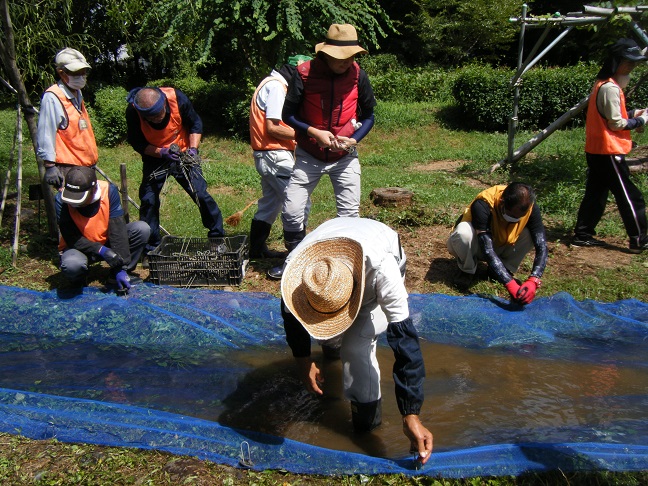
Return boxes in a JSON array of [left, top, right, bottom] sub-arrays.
[[585, 78, 632, 155]]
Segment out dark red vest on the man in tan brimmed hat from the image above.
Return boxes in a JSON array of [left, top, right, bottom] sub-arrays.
[[296, 58, 360, 162]]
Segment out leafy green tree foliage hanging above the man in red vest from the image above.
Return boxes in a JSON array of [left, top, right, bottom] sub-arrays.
[[142, 0, 392, 79]]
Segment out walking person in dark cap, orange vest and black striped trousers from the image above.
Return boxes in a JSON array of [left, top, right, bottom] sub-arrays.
[[572, 39, 648, 253]]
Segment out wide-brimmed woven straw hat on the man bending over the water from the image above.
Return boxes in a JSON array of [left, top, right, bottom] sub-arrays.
[[281, 237, 365, 339]]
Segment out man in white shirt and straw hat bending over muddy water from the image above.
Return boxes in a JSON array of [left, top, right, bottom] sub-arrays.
[[281, 218, 433, 464]]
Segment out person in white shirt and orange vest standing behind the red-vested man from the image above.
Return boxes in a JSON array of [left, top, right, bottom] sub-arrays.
[[250, 55, 312, 258]]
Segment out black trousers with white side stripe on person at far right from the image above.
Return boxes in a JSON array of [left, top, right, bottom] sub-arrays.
[[574, 154, 646, 244]]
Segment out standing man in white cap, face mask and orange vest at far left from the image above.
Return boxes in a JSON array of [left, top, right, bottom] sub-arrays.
[[36, 47, 99, 189]]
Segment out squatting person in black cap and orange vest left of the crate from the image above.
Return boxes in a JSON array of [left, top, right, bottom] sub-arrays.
[[55, 166, 150, 291]]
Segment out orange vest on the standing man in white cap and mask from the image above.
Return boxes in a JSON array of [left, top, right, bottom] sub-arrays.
[[47, 84, 99, 167]]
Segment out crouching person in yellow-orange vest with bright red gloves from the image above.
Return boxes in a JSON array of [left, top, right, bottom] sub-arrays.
[[447, 182, 548, 304]]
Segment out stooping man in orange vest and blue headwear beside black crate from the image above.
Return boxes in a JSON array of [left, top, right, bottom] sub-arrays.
[[126, 86, 225, 253]]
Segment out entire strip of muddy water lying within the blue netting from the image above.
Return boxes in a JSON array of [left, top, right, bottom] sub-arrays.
[[0, 342, 648, 458]]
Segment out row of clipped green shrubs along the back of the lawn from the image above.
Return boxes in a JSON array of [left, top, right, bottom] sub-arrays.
[[91, 54, 648, 146]]
